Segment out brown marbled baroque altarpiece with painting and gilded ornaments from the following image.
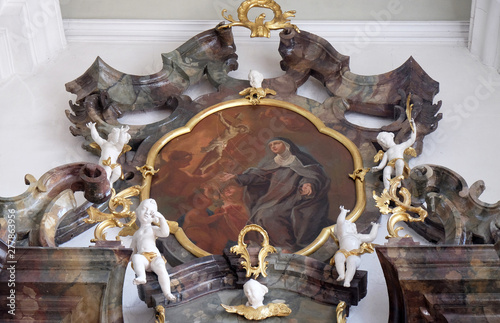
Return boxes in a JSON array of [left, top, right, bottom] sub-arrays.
[[0, 0, 500, 322]]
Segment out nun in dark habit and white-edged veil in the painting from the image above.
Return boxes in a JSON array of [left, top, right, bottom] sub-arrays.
[[222, 137, 330, 252]]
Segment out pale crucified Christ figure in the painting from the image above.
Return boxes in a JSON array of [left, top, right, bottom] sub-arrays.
[[197, 112, 249, 174]]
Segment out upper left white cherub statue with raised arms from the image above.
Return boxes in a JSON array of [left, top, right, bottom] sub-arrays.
[[87, 122, 131, 185]]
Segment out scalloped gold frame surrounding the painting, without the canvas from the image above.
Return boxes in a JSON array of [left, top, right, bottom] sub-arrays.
[[140, 98, 366, 257]]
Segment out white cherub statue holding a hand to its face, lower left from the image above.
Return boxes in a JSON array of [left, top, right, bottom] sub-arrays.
[[131, 199, 175, 301]]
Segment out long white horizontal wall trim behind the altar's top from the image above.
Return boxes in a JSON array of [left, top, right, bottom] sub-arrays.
[[63, 19, 469, 46]]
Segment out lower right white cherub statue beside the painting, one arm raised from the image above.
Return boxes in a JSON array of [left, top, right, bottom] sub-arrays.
[[330, 206, 380, 287]]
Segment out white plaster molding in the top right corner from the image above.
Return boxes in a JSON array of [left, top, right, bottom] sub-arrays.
[[469, 0, 500, 70]]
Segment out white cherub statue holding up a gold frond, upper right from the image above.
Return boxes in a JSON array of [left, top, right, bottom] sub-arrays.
[[371, 119, 417, 189]]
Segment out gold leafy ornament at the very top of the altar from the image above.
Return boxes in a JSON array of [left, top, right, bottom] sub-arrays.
[[220, 0, 300, 38]]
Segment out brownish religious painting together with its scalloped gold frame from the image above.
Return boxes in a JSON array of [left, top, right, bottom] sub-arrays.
[[141, 99, 366, 257]]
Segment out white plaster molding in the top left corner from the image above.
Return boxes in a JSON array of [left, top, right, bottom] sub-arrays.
[[0, 0, 66, 81]]
